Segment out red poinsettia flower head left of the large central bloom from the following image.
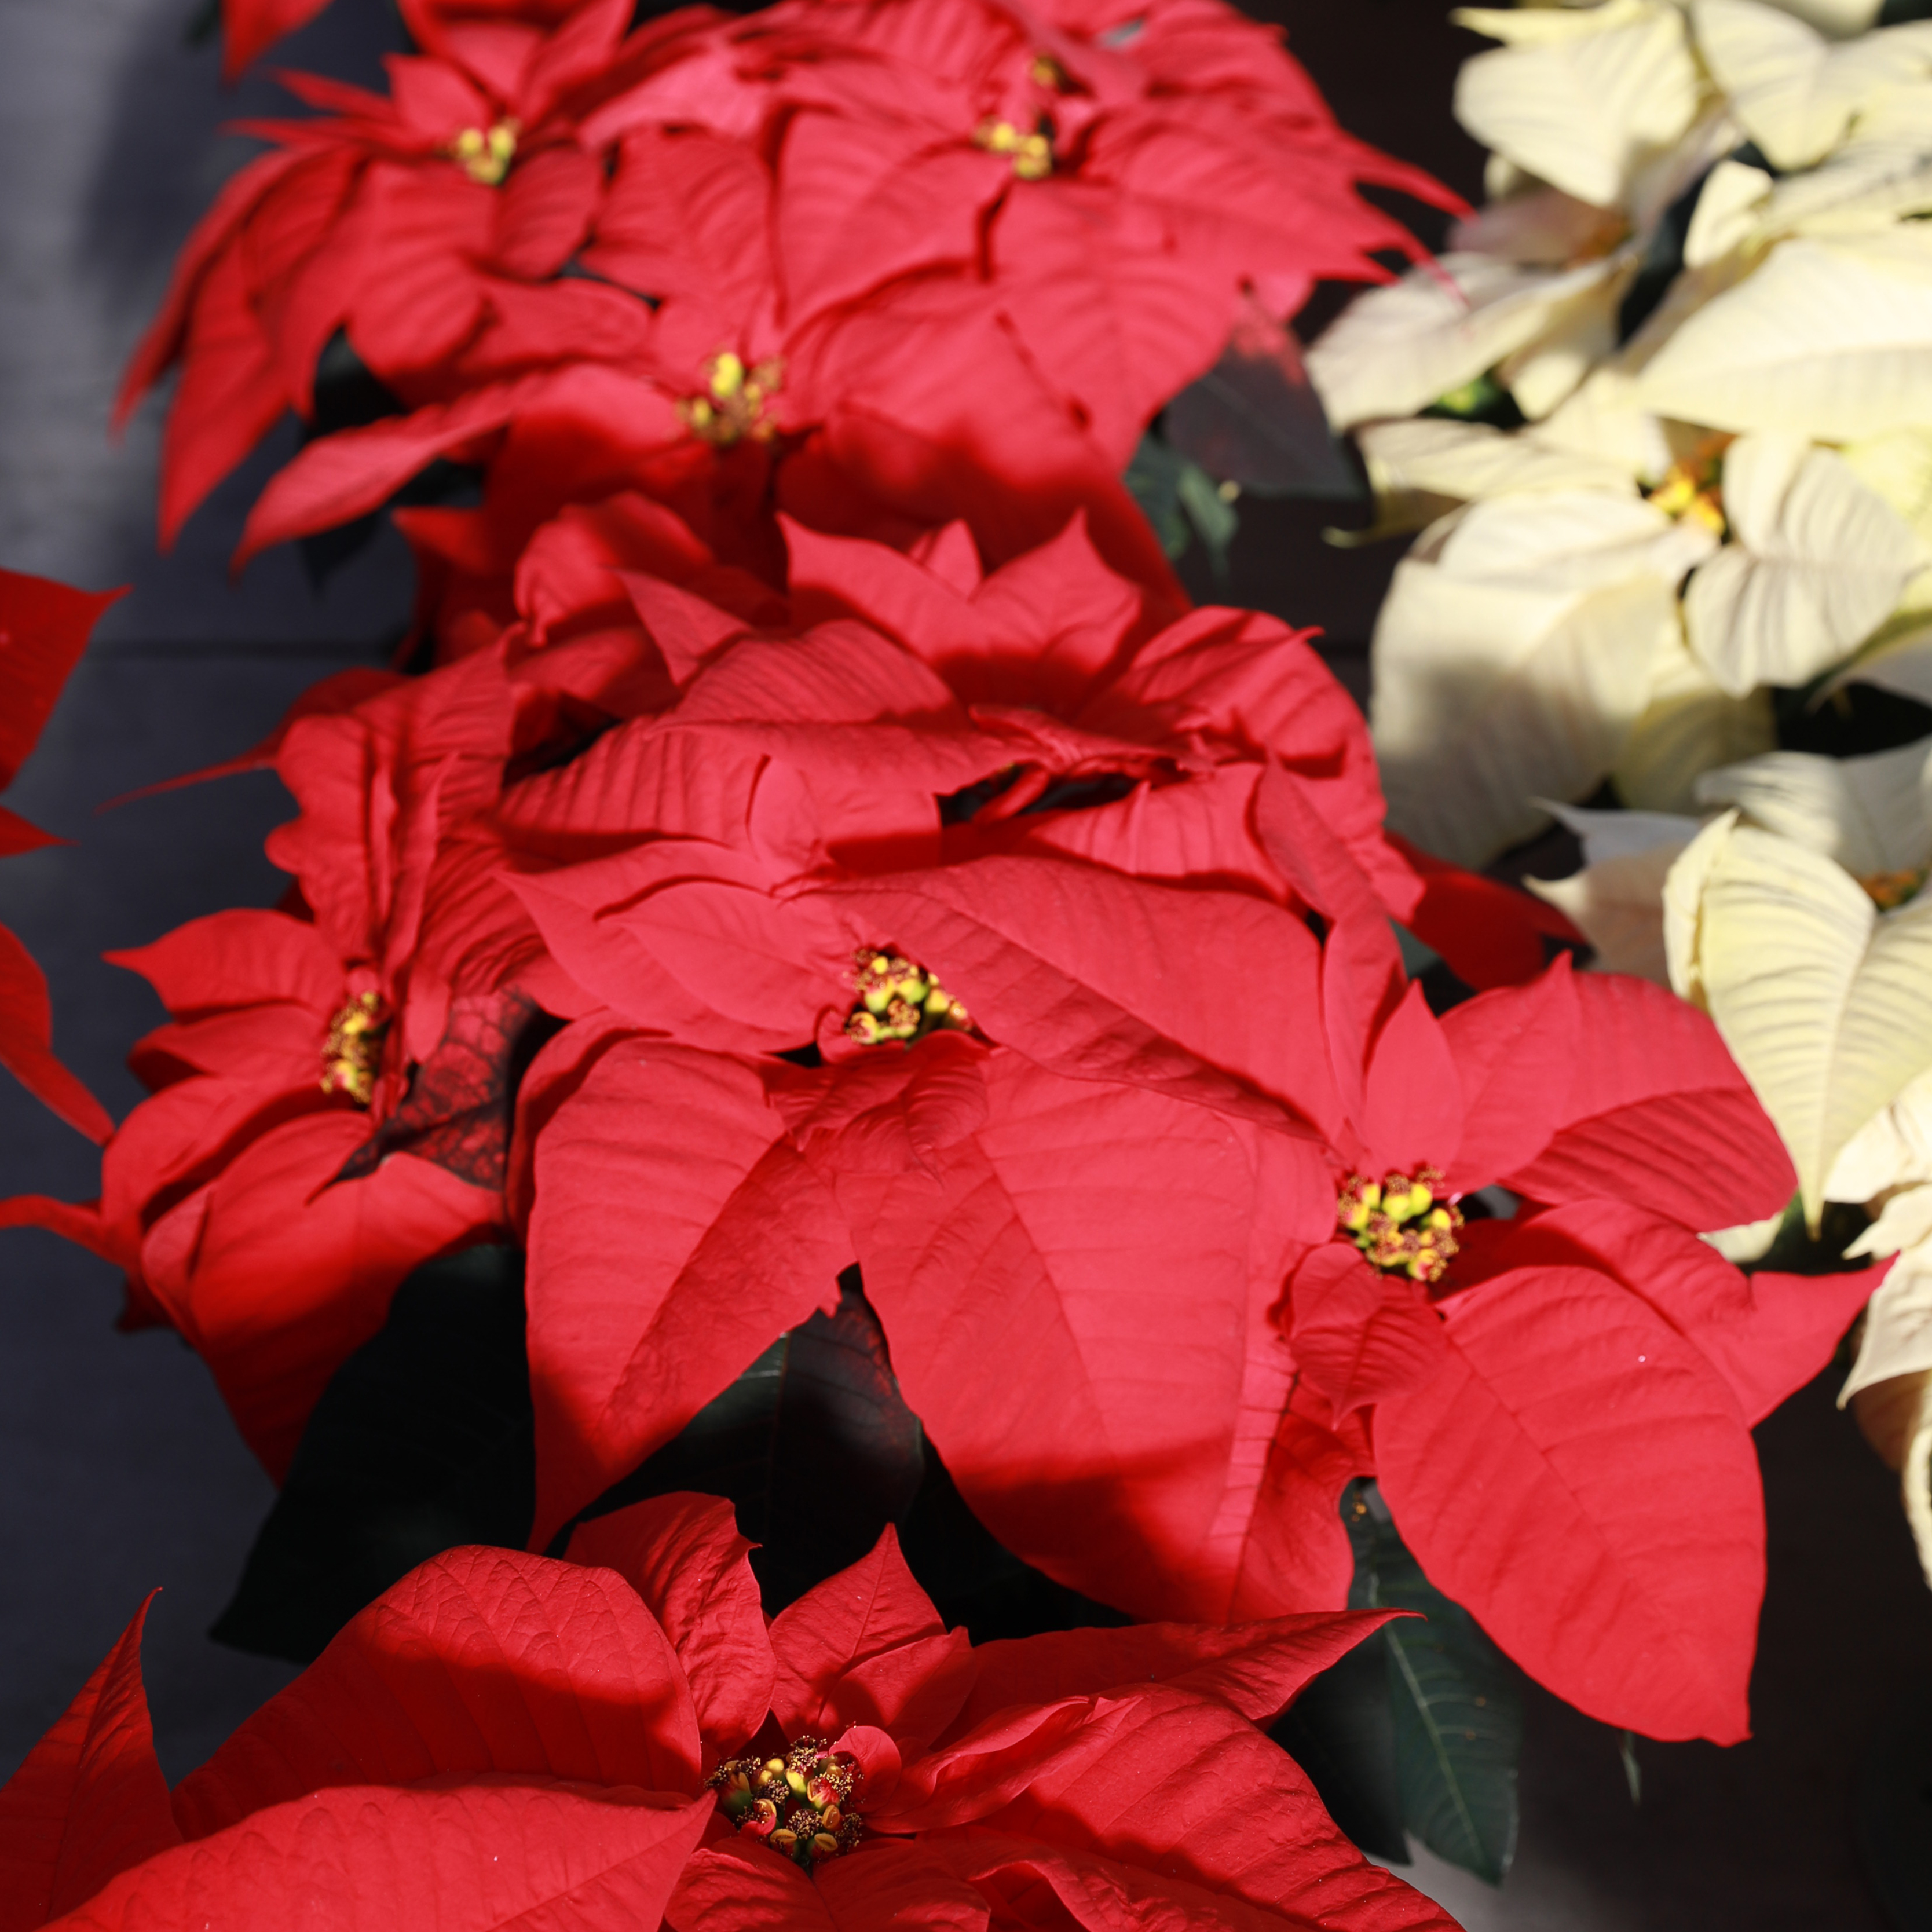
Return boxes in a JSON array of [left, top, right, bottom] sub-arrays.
[[4, 651, 634, 1474]]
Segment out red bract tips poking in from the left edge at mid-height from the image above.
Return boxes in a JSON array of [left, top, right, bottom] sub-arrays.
[[0, 570, 122, 1140]]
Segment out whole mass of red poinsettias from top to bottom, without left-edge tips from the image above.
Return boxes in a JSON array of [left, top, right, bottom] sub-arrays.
[[0, 0, 1870, 1932]]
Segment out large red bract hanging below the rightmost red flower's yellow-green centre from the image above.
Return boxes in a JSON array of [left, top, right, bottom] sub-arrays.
[[1375, 1267, 1764, 1744]]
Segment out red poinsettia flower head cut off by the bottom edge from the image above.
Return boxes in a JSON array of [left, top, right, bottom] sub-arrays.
[[0, 1495, 1451, 1932]]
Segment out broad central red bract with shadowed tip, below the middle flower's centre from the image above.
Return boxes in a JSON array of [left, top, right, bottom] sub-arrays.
[[840, 1051, 1341, 1617]]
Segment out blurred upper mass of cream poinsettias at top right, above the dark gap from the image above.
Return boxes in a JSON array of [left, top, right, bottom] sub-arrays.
[[1308, 0, 1932, 869]]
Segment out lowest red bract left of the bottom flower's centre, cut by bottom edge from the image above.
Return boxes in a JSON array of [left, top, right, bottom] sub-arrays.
[[56, 1779, 711, 1932]]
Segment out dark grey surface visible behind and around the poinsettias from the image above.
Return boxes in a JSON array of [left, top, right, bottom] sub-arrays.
[[0, 0, 1932, 1932]]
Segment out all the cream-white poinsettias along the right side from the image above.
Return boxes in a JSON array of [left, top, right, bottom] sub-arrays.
[[1308, 0, 1932, 1576]]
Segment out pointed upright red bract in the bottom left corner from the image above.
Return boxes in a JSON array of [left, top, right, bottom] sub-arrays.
[[0, 1592, 182, 1932]]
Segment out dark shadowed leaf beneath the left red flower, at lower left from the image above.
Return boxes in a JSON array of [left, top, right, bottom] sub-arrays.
[[208, 1246, 537, 1663]]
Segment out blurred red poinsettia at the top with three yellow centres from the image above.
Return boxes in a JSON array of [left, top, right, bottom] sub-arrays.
[[126, 0, 1453, 602]]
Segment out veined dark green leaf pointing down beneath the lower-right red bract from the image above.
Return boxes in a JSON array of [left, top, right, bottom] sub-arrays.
[[1343, 1482, 1523, 1886]]
